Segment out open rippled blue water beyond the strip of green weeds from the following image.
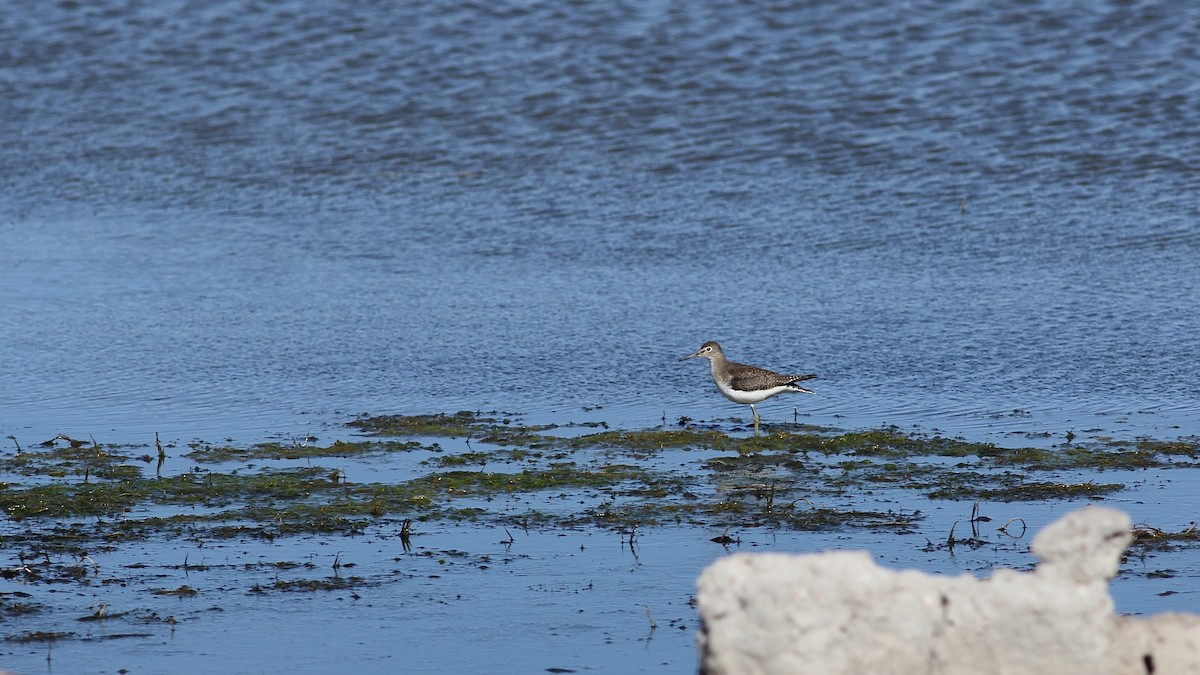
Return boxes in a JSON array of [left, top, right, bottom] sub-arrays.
[[0, 0, 1200, 667]]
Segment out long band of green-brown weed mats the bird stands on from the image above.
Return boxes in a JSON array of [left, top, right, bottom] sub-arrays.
[[0, 411, 1196, 540]]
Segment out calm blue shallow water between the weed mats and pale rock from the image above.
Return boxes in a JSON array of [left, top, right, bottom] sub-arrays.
[[0, 425, 1200, 673]]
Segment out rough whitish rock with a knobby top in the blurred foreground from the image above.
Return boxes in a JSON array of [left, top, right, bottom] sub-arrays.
[[697, 507, 1200, 675]]
